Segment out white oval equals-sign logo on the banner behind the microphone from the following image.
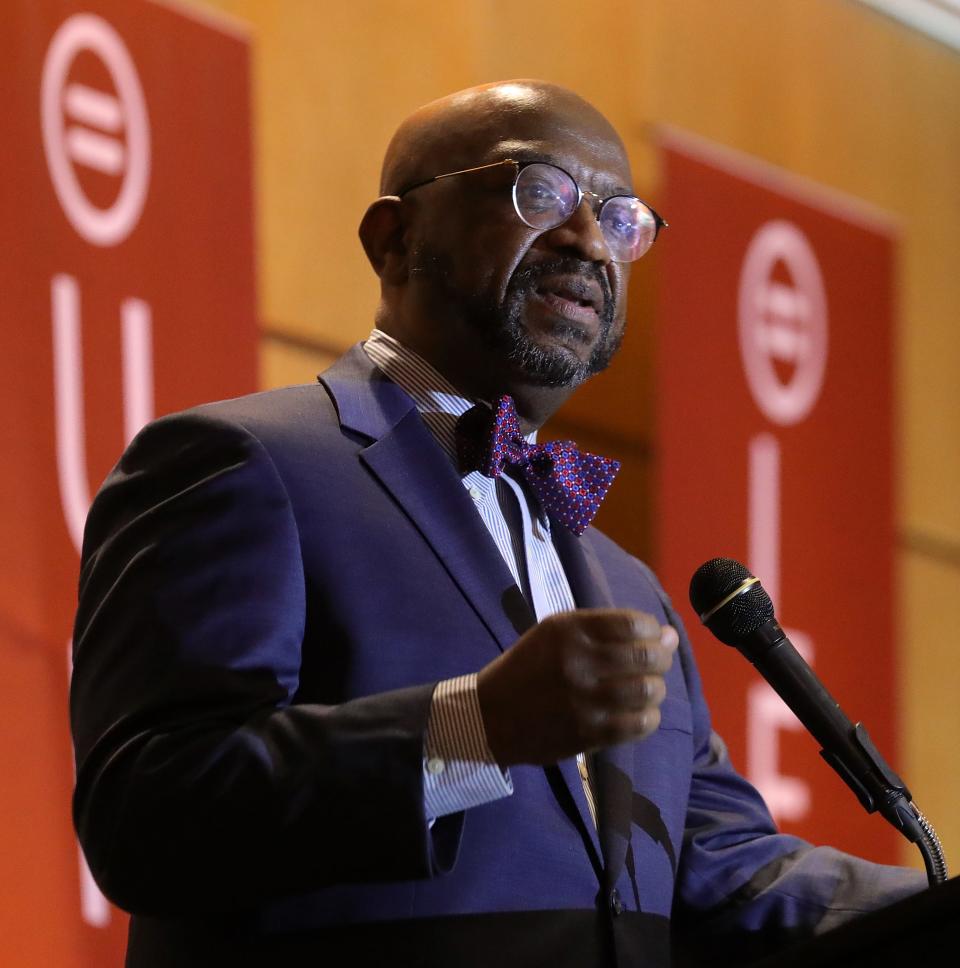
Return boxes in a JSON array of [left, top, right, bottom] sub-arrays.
[[738, 220, 827, 426]]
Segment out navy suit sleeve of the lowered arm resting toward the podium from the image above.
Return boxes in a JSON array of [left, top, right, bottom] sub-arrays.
[[640, 579, 926, 960]]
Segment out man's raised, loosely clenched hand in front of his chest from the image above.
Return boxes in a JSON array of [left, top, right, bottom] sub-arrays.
[[477, 608, 679, 767]]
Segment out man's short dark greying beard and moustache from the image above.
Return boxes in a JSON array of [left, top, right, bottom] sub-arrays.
[[410, 247, 623, 387]]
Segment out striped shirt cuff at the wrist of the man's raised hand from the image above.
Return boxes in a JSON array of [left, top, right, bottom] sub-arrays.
[[423, 673, 513, 819]]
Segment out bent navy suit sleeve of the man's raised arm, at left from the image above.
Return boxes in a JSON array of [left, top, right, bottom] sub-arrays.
[[71, 415, 460, 914]]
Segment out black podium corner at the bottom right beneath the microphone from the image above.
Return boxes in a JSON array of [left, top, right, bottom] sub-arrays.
[[750, 877, 960, 968]]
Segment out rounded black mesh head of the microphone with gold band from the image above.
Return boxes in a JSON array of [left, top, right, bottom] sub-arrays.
[[690, 558, 774, 646]]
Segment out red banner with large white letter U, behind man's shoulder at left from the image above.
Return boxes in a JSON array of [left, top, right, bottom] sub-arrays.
[[0, 0, 256, 968]]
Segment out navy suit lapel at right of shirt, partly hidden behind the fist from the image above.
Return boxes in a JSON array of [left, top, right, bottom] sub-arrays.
[[553, 527, 633, 887]]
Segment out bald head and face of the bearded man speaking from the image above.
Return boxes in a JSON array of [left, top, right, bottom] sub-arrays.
[[360, 80, 634, 427]]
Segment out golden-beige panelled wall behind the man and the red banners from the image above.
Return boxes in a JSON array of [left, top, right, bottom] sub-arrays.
[[190, 0, 960, 861]]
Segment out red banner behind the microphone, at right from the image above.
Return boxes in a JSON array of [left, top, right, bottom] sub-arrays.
[[655, 133, 899, 862]]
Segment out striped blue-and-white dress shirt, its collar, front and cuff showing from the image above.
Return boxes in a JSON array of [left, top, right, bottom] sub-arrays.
[[363, 329, 594, 818]]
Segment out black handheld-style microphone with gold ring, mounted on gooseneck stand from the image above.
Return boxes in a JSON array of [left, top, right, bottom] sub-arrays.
[[690, 558, 932, 843]]
